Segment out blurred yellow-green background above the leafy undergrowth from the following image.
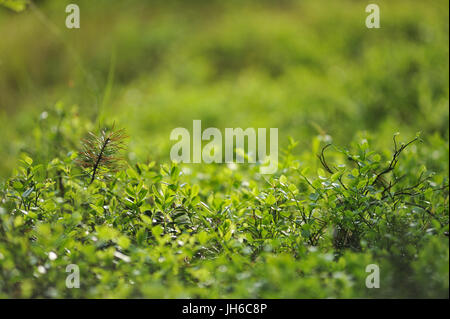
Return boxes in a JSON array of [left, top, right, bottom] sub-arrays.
[[0, 0, 449, 179]]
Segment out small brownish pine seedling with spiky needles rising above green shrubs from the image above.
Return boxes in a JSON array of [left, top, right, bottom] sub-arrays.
[[77, 125, 128, 185]]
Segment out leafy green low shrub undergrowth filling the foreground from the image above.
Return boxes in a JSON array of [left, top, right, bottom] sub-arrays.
[[0, 115, 449, 298]]
